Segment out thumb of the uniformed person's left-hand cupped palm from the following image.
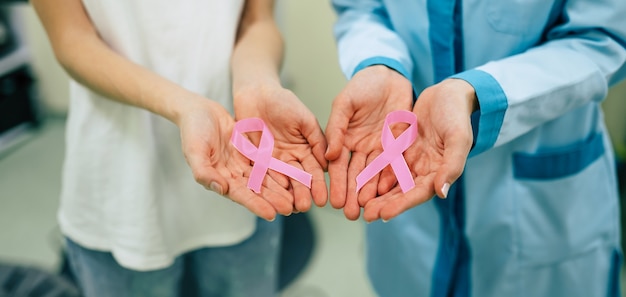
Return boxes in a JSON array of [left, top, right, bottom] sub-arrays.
[[325, 94, 354, 161]]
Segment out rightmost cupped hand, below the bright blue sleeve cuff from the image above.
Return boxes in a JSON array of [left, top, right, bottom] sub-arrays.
[[363, 79, 478, 221]]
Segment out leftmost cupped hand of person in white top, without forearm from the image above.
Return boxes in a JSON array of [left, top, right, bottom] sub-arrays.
[[176, 97, 293, 221]]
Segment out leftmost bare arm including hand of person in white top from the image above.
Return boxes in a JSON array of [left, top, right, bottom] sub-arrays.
[[31, 0, 293, 220]]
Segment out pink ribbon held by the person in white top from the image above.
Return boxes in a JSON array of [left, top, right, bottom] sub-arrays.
[[230, 118, 311, 193]]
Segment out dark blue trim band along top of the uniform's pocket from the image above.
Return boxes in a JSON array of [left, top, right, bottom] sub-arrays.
[[513, 133, 605, 180]]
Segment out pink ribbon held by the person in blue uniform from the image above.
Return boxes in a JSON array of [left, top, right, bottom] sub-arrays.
[[356, 110, 417, 193]]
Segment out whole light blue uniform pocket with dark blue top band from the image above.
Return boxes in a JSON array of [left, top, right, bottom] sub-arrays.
[[512, 133, 619, 267]]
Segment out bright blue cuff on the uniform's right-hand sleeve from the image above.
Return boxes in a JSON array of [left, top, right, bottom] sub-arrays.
[[451, 69, 508, 157]]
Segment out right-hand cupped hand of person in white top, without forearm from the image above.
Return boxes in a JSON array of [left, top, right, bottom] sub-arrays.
[[234, 83, 328, 212]]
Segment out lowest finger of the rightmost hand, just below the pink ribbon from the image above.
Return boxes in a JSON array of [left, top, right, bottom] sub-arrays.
[[380, 176, 435, 221]]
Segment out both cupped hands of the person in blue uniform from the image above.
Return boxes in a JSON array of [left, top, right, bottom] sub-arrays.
[[326, 65, 478, 221]]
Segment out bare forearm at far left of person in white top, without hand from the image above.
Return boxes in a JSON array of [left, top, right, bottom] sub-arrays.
[[32, 0, 200, 122]]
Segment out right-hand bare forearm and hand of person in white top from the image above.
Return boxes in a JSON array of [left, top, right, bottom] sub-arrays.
[[231, 0, 328, 212]]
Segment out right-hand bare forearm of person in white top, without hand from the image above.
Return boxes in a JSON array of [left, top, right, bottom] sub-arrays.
[[231, 1, 283, 99]]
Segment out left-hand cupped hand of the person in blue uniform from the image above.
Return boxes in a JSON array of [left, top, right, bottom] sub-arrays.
[[326, 65, 413, 220]]
